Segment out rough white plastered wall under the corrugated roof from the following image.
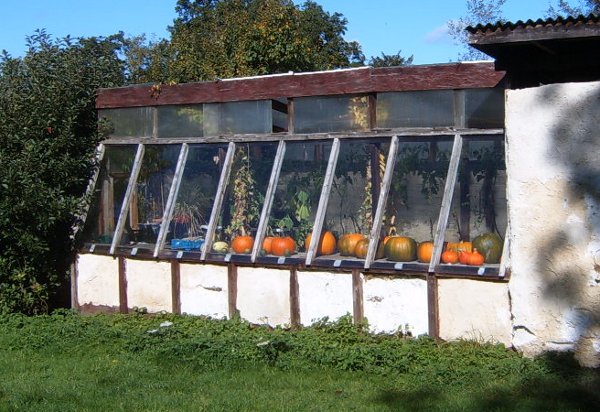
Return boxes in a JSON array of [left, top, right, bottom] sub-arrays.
[[506, 82, 600, 365]]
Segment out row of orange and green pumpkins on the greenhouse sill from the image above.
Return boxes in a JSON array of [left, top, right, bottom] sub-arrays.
[[231, 231, 503, 266]]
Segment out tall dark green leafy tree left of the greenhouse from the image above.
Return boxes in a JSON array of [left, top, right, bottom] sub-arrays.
[[0, 31, 124, 313]]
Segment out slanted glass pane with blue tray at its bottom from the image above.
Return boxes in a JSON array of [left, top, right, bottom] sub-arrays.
[[166, 144, 227, 250]]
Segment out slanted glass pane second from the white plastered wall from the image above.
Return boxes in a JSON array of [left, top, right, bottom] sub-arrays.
[[372, 138, 452, 264]]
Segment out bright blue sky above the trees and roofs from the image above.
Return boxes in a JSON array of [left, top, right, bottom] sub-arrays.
[[0, 0, 577, 64]]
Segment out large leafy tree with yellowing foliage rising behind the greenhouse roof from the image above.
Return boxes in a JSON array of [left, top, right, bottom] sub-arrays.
[[159, 0, 364, 82]]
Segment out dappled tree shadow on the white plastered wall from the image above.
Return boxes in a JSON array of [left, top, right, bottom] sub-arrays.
[[536, 83, 600, 366]]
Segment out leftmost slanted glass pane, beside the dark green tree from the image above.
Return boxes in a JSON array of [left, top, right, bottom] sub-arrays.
[[82, 145, 137, 244]]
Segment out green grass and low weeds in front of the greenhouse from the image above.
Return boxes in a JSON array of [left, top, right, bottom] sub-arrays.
[[0, 312, 600, 412]]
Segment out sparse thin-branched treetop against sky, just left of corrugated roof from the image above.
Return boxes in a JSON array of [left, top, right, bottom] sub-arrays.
[[447, 0, 506, 60]]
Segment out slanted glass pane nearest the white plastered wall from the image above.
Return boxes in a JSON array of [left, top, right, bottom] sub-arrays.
[[444, 136, 507, 264]]
